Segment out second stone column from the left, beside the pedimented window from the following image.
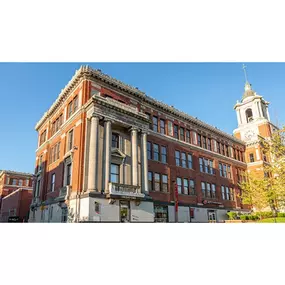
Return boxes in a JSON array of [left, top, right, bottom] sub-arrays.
[[103, 120, 112, 192]]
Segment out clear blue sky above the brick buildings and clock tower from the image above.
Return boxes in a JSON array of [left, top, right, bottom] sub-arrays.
[[0, 63, 285, 172]]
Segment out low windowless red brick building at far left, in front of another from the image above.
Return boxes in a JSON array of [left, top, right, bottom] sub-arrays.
[[0, 187, 33, 222]]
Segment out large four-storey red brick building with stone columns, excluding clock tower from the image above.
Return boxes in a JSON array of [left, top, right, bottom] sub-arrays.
[[30, 67, 256, 222]]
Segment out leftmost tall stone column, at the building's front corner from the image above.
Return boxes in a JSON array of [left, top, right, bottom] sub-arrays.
[[88, 116, 99, 191]]
